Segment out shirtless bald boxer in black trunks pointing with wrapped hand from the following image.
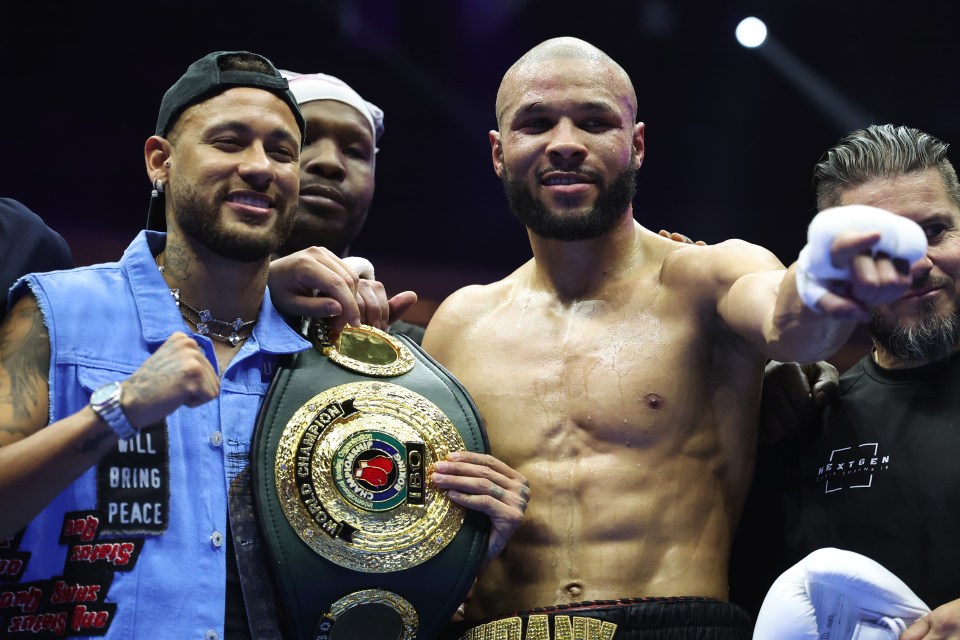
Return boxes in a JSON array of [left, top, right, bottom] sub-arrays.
[[424, 38, 925, 638]]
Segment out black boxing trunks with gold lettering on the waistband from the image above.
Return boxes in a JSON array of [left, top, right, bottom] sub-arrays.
[[444, 597, 753, 640]]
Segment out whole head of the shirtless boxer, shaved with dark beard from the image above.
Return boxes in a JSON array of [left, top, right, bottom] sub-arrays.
[[488, 38, 644, 241]]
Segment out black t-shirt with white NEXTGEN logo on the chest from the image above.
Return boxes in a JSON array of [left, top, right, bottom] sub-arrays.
[[783, 355, 960, 608]]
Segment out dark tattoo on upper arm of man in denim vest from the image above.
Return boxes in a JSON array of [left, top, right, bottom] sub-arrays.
[[0, 298, 50, 423]]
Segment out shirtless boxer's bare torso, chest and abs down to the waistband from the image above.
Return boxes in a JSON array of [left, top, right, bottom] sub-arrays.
[[451, 282, 763, 619]]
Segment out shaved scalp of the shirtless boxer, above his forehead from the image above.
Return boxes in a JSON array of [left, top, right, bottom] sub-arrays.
[[496, 37, 637, 128]]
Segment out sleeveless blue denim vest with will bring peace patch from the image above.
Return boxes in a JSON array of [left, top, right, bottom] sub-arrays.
[[0, 231, 310, 640]]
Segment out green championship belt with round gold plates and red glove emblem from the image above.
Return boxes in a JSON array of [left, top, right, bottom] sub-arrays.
[[251, 322, 490, 640]]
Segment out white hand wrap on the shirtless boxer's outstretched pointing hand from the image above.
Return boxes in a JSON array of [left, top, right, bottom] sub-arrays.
[[797, 204, 927, 311]]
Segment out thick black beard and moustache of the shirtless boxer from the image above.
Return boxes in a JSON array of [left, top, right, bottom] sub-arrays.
[[502, 154, 637, 241]]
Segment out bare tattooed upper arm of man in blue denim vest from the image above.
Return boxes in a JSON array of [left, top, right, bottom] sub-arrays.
[[0, 294, 50, 446]]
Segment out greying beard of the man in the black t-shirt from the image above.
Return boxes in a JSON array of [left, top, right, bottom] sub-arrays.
[[870, 277, 960, 362]]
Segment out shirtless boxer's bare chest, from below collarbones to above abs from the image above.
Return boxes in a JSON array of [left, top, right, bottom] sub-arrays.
[[464, 292, 704, 446]]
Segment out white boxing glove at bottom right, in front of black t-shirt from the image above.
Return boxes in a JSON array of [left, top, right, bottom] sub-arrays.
[[753, 548, 930, 640]]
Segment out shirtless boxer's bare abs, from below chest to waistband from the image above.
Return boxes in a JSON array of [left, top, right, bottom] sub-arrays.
[[468, 452, 732, 619]]
